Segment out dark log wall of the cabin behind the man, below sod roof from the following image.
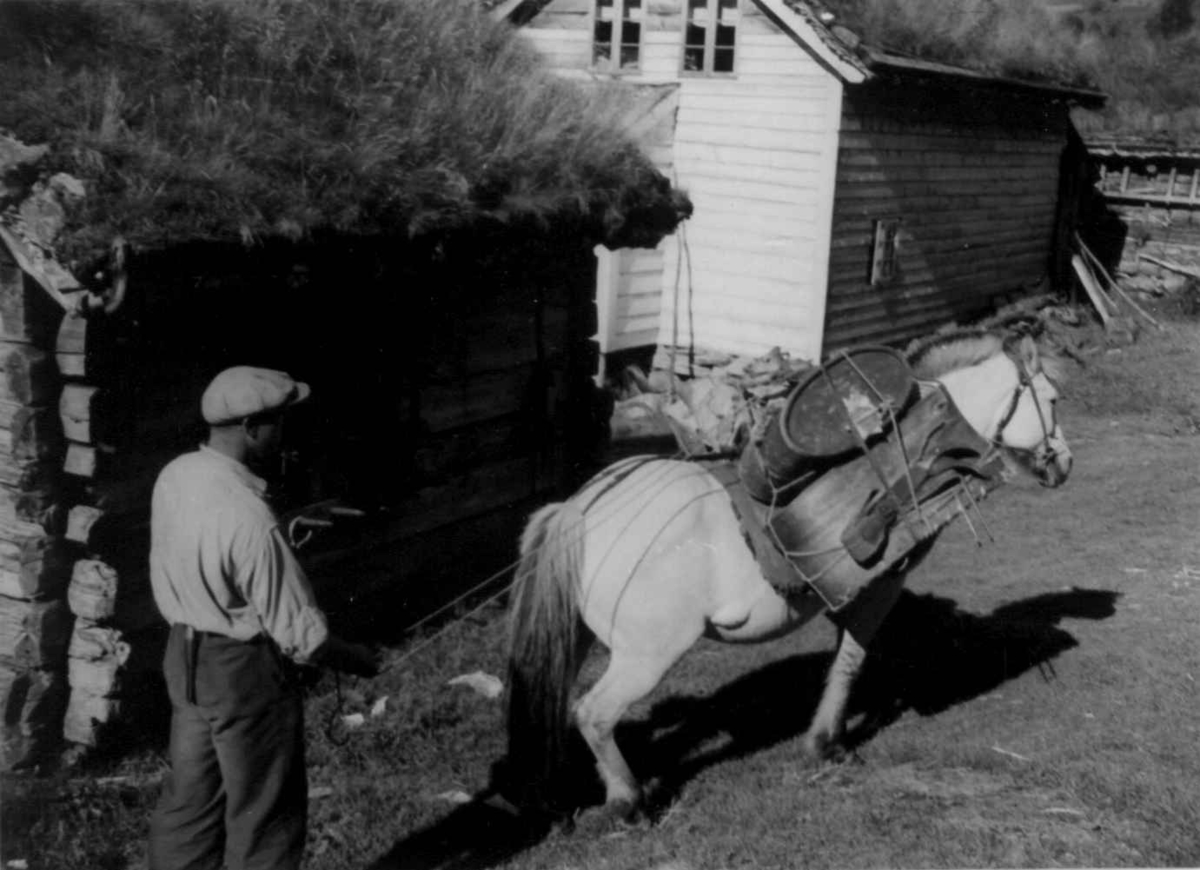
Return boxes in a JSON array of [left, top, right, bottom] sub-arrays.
[[0, 234, 604, 746]]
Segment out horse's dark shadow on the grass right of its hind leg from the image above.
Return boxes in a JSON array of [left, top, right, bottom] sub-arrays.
[[624, 588, 1120, 808]]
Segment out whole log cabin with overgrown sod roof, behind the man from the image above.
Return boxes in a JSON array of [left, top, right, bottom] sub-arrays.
[[0, 0, 690, 764]]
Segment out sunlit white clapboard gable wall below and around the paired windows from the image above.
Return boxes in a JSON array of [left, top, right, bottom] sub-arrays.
[[523, 0, 841, 359]]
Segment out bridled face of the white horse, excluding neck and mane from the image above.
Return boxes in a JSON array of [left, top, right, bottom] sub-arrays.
[[984, 336, 1072, 486]]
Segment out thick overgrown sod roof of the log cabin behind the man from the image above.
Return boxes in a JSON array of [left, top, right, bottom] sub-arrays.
[[0, 0, 690, 270]]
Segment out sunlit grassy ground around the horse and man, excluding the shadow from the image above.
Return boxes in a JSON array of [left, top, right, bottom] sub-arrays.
[[2, 309, 1200, 870]]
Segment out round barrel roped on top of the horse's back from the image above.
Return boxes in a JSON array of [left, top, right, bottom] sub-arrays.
[[738, 346, 918, 504]]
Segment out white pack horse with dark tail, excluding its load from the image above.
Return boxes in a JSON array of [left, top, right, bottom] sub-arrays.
[[506, 332, 1072, 816]]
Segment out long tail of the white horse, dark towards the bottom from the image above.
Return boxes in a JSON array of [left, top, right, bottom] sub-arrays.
[[506, 503, 586, 811]]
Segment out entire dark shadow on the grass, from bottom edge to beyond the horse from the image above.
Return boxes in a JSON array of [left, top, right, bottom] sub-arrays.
[[372, 588, 1118, 870]]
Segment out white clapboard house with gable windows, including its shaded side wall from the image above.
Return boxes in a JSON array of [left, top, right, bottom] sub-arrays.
[[494, 0, 1103, 361]]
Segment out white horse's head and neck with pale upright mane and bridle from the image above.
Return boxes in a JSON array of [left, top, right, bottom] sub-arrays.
[[910, 332, 1072, 486]]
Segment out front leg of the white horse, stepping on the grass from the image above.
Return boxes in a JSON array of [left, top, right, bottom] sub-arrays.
[[804, 571, 907, 758]]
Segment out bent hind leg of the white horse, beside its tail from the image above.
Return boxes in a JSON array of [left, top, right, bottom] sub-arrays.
[[575, 632, 698, 817]]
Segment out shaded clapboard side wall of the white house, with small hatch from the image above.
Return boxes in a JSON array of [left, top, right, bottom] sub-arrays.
[[826, 82, 1068, 349]]
